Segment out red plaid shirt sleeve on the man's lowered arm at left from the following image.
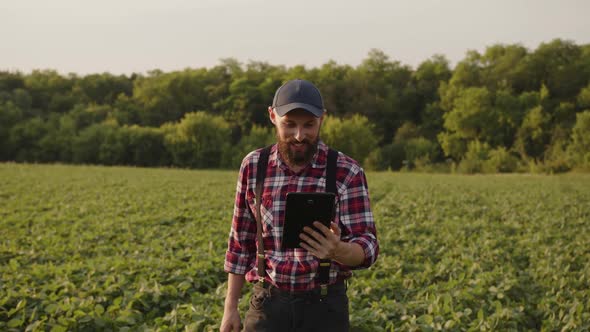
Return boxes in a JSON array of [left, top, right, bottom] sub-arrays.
[[224, 155, 256, 274]]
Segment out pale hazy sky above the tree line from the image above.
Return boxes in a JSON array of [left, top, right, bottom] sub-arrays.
[[0, 0, 590, 74]]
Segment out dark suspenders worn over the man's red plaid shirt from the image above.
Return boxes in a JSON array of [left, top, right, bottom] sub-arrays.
[[255, 145, 338, 295]]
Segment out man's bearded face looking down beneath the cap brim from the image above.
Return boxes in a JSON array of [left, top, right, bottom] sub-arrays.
[[268, 107, 323, 166]]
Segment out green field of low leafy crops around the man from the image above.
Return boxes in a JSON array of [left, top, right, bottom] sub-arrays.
[[0, 164, 590, 331]]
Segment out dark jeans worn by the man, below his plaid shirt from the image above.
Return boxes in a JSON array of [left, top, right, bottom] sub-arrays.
[[244, 281, 350, 332]]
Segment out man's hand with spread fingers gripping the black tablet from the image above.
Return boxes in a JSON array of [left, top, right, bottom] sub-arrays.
[[299, 221, 343, 259]]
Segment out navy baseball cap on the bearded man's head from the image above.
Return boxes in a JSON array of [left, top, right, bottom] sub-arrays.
[[272, 79, 326, 118]]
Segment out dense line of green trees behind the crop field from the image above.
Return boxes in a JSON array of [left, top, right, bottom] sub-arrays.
[[0, 39, 590, 173]]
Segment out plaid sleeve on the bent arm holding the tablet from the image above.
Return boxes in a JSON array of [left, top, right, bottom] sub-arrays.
[[339, 168, 379, 269]]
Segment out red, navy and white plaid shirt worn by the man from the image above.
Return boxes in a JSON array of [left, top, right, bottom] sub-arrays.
[[224, 141, 379, 291]]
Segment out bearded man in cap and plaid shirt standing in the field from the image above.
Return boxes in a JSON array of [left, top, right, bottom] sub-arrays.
[[220, 79, 379, 332]]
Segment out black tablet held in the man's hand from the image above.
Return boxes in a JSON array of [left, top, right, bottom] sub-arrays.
[[282, 192, 336, 249]]
